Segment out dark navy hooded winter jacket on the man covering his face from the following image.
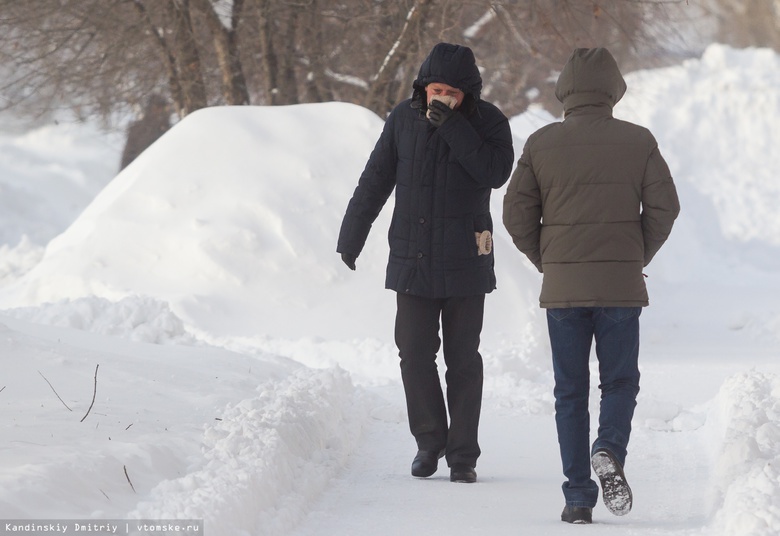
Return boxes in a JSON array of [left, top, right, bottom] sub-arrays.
[[337, 47, 514, 298]]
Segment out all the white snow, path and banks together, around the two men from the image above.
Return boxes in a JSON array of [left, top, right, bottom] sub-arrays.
[[0, 45, 780, 536]]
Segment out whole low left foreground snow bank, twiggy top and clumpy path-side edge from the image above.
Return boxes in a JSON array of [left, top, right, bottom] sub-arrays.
[[0, 310, 366, 535]]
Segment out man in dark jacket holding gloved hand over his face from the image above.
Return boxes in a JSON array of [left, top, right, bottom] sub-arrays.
[[337, 43, 514, 482]]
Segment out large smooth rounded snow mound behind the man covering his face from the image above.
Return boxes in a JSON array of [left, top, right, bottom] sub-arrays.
[[0, 103, 538, 340]]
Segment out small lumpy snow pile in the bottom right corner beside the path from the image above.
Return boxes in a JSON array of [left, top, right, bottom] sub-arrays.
[[712, 372, 780, 536]]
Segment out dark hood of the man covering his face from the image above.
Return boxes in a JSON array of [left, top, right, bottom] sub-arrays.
[[412, 43, 482, 100]]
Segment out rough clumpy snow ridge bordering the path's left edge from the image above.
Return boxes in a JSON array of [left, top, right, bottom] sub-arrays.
[[129, 369, 367, 536]]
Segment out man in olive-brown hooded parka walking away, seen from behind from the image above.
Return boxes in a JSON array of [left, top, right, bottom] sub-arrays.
[[503, 48, 680, 523]]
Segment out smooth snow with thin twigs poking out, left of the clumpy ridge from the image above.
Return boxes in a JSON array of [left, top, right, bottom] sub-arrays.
[[0, 318, 298, 519]]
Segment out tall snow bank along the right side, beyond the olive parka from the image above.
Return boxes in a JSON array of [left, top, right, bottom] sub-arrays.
[[615, 45, 780, 536]]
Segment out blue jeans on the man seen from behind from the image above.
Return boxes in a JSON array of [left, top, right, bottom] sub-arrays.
[[547, 307, 642, 508]]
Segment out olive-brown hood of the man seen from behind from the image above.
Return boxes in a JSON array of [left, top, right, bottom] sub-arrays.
[[555, 48, 626, 112]]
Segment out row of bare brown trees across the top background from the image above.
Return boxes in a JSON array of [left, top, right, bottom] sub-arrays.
[[0, 0, 696, 127]]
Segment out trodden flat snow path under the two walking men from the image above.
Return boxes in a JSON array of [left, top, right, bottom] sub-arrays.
[[291, 352, 724, 536]]
